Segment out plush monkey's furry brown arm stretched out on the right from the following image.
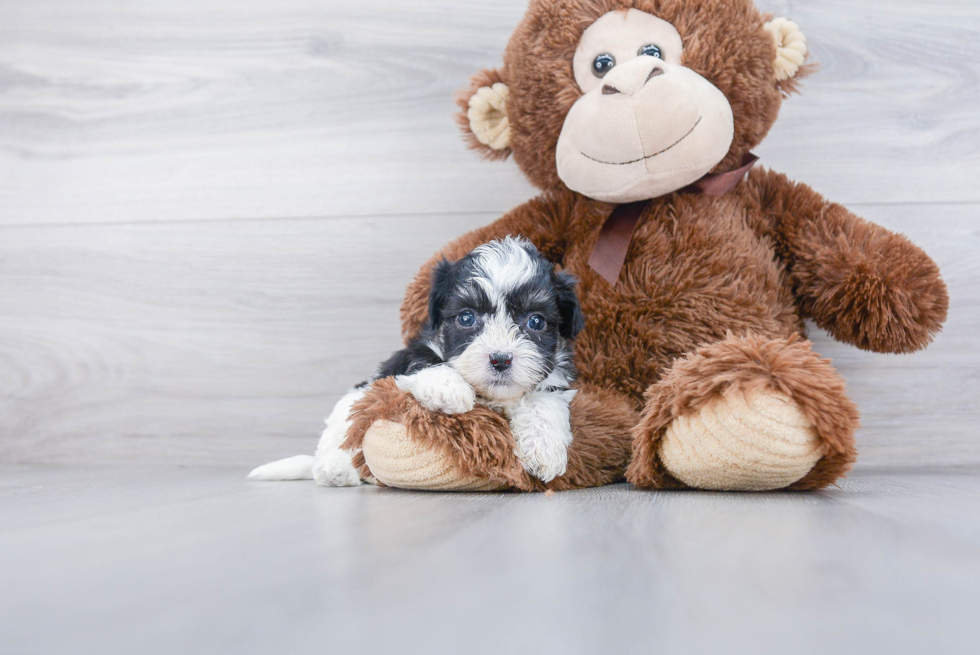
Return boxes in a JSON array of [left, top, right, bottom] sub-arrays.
[[747, 171, 949, 353]]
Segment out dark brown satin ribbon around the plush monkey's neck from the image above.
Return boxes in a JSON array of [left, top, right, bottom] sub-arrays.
[[589, 153, 759, 286]]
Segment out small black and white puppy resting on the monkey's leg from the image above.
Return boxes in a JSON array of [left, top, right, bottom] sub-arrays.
[[249, 237, 584, 486]]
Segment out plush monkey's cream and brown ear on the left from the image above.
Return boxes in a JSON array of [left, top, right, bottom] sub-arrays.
[[456, 70, 510, 159]]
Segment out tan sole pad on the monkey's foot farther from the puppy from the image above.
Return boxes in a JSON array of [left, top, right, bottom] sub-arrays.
[[660, 389, 823, 491]]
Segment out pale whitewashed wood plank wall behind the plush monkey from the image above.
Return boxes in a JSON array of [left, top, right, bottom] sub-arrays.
[[0, 0, 980, 466]]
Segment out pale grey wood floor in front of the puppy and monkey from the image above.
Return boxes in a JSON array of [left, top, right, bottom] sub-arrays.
[[0, 466, 980, 655]]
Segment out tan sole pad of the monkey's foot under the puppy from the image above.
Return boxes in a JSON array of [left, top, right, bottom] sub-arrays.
[[363, 420, 506, 491]]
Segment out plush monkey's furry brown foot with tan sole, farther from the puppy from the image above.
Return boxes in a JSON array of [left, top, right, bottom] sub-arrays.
[[626, 335, 858, 491]]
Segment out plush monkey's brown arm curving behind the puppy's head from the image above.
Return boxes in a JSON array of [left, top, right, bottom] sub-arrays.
[[401, 193, 575, 342]]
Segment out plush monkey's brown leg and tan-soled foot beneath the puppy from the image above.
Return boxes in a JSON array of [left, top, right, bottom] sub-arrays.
[[342, 378, 639, 491]]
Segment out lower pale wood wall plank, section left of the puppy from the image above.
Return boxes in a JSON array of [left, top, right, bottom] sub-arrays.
[[0, 216, 492, 465]]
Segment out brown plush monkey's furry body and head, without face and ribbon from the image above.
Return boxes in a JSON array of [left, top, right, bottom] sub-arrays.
[[347, 0, 948, 491]]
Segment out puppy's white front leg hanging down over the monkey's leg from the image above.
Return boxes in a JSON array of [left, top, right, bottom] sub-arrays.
[[508, 391, 575, 482]]
